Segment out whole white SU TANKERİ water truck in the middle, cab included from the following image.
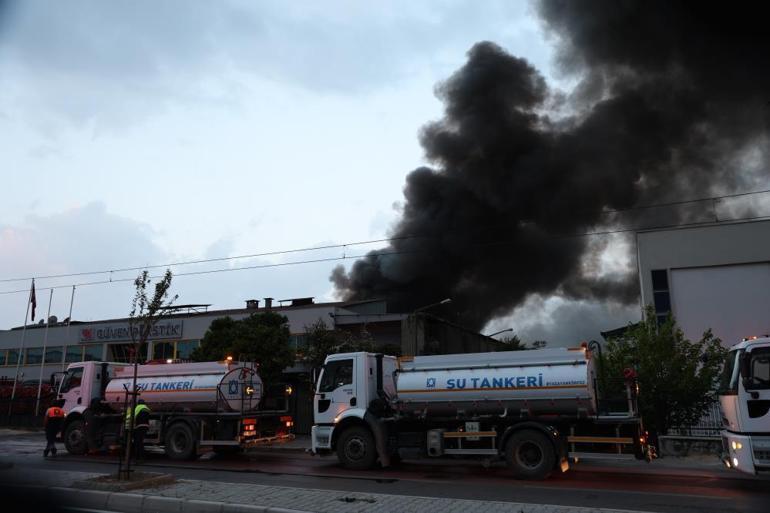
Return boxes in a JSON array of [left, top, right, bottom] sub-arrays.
[[312, 347, 654, 479]]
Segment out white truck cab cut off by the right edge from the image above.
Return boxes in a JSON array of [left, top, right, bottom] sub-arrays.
[[719, 336, 770, 475]]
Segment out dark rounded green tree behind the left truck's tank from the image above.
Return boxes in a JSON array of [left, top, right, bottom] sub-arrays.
[[191, 312, 294, 383]]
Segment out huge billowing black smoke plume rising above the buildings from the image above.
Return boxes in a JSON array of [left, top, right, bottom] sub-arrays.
[[331, 0, 770, 328]]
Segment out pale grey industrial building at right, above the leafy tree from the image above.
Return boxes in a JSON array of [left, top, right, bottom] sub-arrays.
[[636, 220, 770, 346]]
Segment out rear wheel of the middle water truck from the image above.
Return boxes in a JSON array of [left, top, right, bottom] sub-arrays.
[[505, 429, 556, 479]]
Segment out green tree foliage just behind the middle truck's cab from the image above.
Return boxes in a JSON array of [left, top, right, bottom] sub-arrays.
[[303, 319, 380, 368]]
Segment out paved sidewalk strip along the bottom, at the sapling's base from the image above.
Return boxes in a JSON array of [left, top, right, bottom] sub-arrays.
[[0, 469, 656, 513]]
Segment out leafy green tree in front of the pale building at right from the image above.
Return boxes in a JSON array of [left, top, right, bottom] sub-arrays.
[[603, 307, 727, 442]]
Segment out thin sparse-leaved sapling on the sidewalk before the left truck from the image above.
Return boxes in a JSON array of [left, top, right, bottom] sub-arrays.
[[118, 269, 179, 479]]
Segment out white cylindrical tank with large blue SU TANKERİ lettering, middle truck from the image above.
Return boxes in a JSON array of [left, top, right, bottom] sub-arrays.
[[393, 348, 597, 417]]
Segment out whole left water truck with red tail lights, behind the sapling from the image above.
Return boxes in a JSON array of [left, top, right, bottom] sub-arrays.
[[58, 360, 293, 459]]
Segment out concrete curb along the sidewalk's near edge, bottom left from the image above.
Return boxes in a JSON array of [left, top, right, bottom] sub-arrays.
[[37, 486, 312, 513]]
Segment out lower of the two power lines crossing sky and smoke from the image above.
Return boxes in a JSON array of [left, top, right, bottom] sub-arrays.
[[0, 210, 770, 295]]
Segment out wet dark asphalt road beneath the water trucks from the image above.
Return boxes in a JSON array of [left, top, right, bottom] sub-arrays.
[[0, 428, 770, 513]]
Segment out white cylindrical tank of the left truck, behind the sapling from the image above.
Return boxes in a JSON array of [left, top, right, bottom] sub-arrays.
[[104, 361, 262, 412]]
